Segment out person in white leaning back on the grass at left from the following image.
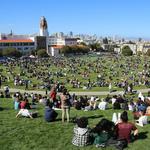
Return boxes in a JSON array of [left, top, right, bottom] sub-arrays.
[[16, 108, 38, 119]]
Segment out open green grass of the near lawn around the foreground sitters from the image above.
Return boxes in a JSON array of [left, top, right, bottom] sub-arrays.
[[0, 99, 150, 150]]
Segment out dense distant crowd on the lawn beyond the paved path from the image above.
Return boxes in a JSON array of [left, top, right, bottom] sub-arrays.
[[0, 56, 150, 93]]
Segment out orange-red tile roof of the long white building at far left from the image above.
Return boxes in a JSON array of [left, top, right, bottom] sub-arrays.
[[0, 39, 33, 43]]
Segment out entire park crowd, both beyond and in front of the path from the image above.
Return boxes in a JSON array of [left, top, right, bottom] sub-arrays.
[[0, 57, 150, 149]]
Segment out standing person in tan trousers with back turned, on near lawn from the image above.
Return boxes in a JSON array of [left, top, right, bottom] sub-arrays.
[[60, 89, 70, 122]]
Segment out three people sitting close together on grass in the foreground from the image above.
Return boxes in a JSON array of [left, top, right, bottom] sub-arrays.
[[72, 111, 138, 149]]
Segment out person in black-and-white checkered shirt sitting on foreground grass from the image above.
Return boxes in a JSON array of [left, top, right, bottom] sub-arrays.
[[72, 117, 91, 146]]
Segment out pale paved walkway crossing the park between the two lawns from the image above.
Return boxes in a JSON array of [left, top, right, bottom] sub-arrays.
[[0, 88, 150, 96]]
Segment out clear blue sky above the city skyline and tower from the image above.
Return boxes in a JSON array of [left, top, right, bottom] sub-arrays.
[[0, 0, 150, 38]]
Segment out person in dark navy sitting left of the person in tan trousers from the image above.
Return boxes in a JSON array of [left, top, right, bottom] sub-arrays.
[[45, 102, 58, 122]]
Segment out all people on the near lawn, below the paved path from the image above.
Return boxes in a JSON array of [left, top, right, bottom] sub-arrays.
[[0, 86, 150, 147]]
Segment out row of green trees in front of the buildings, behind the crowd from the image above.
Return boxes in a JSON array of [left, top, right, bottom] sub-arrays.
[[0, 43, 150, 58]]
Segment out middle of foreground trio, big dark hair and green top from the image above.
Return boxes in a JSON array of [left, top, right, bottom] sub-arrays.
[[92, 118, 115, 147]]
